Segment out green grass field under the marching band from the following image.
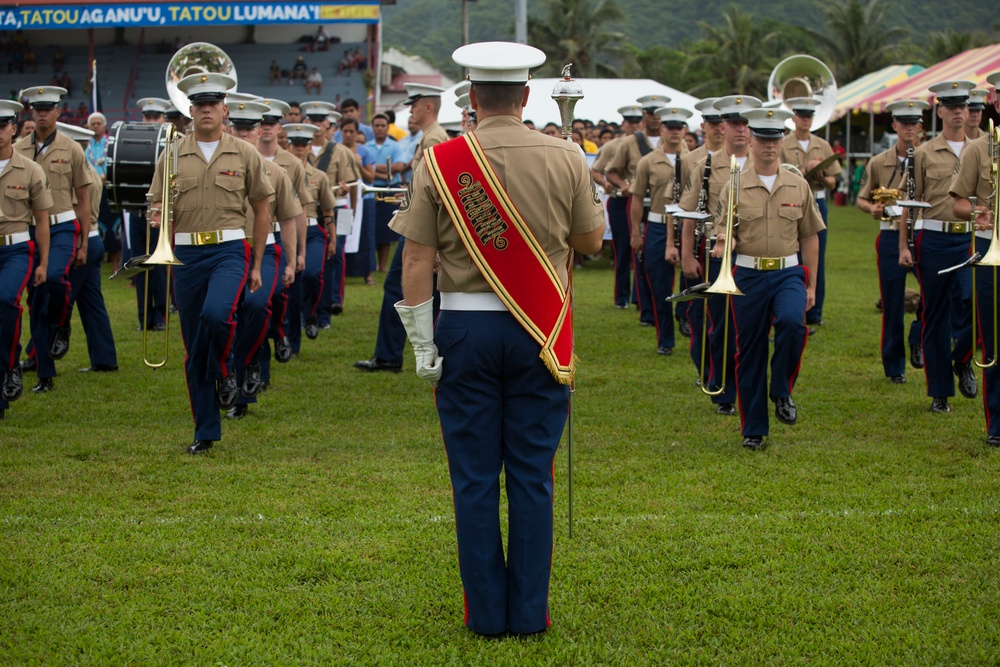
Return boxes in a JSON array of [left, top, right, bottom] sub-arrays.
[[0, 208, 1000, 665]]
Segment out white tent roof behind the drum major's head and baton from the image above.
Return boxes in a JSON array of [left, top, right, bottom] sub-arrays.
[[396, 79, 701, 130]]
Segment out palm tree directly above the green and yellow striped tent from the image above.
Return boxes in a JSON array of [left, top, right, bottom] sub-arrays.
[[805, 0, 906, 83]]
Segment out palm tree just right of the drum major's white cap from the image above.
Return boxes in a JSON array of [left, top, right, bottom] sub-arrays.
[[528, 0, 627, 78]]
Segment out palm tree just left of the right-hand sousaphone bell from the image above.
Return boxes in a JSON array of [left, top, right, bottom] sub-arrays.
[[685, 6, 779, 99]]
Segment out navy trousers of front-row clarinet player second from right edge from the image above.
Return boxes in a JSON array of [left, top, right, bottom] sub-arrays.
[[916, 230, 978, 398]]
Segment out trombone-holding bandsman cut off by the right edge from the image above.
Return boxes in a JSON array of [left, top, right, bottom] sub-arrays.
[[949, 71, 1000, 447]]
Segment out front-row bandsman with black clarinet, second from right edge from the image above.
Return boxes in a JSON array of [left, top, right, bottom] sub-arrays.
[[900, 81, 978, 412]]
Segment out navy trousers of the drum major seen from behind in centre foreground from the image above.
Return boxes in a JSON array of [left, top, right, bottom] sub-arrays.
[[434, 310, 569, 634]]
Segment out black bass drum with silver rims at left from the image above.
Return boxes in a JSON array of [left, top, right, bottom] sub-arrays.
[[107, 121, 169, 212]]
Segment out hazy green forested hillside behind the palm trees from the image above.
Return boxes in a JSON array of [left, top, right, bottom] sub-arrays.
[[384, 0, 1000, 80]]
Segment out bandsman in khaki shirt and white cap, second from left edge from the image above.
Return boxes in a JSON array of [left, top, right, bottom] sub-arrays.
[[14, 86, 94, 393]]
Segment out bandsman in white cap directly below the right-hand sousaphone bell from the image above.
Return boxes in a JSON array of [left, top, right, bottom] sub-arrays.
[[781, 97, 843, 325]]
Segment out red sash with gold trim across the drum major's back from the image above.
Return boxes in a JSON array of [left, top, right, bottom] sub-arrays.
[[424, 133, 575, 384]]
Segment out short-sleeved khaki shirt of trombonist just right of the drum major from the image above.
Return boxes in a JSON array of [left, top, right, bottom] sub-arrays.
[[713, 164, 826, 257]]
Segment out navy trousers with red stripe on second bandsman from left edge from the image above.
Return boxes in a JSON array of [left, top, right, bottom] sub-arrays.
[[28, 220, 80, 380]]
